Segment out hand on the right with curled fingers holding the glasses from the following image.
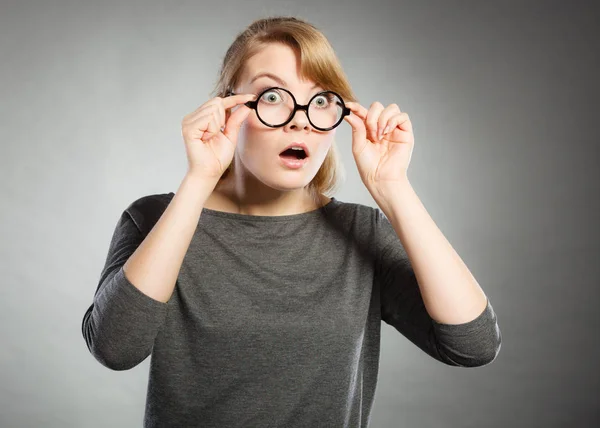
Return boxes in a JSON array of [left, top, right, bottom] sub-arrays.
[[344, 102, 415, 194]]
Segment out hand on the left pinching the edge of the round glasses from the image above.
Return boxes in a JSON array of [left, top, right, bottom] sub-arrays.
[[181, 94, 256, 181]]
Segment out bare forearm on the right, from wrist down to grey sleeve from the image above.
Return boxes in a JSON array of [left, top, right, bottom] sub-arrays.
[[375, 179, 487, 324]]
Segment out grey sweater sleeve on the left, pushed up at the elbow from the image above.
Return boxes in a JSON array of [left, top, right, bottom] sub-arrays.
[[81, 206, 167, 370]]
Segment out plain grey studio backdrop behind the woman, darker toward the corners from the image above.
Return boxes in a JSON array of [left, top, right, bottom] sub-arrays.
[[0, 0, 600, 428]]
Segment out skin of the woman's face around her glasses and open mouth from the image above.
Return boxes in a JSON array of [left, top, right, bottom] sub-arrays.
[[235, 43, 335, 191]]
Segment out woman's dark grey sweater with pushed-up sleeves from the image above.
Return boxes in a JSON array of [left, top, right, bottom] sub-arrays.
[[82, 193, 501, 428]]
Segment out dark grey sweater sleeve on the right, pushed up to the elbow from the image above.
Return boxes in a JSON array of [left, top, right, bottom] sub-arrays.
[[375, 209, 501, 367]]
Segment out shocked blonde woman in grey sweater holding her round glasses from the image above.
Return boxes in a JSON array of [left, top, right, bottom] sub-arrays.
[[82, 18, 501, 428]]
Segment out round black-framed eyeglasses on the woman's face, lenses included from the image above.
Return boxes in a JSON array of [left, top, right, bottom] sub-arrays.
[[228, 87, 350, 131]]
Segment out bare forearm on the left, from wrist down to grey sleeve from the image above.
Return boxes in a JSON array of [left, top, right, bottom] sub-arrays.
[[123, 174, 216, 302]]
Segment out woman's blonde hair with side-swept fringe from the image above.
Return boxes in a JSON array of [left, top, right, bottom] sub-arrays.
[[213, 16, 356, 200]]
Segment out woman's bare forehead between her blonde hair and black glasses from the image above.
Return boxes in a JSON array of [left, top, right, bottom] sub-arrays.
[[241, 43, 315, 87]]
